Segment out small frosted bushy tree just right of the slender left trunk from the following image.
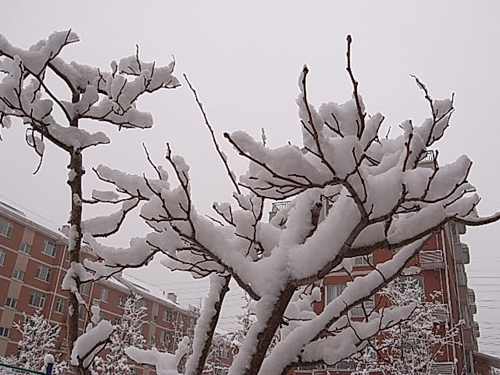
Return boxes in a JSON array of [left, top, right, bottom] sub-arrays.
[[94, 293, 147, 375]]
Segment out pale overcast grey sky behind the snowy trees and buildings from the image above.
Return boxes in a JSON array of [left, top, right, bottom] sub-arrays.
[[0, 0, 500, 355]]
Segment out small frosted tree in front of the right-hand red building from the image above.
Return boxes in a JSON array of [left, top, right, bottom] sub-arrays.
[[358, 277, 460, 375]]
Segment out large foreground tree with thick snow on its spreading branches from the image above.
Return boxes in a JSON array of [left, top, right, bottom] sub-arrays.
[[81, 37, 500, 375]]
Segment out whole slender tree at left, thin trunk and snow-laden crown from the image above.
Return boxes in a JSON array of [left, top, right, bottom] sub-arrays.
[[0, 30, 179, 374]]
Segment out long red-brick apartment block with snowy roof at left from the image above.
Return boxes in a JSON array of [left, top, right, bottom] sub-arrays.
[[0, 202, 199, 375]]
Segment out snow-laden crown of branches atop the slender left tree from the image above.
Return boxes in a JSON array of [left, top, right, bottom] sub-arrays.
[[0, 30, 180, 157]]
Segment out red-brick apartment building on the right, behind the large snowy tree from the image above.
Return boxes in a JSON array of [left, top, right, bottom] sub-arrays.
[[310, 223, 479, 375]]
